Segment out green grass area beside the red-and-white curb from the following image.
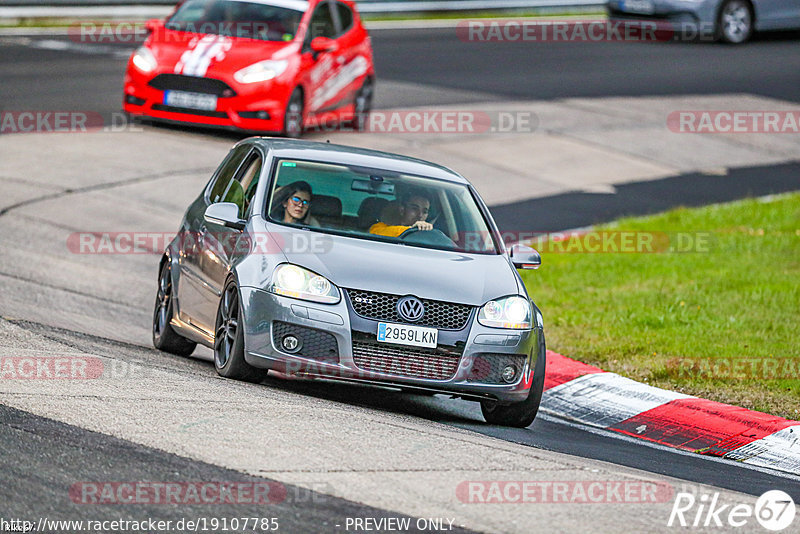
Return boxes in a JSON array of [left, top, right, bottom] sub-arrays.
[[523, 194, 800, 419]]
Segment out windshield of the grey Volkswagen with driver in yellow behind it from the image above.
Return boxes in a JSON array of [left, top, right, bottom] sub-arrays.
[[267, 159, 497, 254]]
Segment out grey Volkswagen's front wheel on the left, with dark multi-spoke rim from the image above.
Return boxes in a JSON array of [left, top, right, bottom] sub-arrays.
[[214, 279, 267, 383]]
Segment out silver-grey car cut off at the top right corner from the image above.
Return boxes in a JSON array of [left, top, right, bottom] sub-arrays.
[[607, 0, 800, 44]]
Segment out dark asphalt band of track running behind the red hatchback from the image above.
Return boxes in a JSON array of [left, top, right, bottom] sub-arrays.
[[0, 28, 800, 114]]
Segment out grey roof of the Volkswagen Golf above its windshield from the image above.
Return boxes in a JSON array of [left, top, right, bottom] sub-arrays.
[[242, 137, 469, 184]]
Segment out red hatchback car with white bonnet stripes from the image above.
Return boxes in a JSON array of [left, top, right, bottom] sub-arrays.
[[123, 0, 375, 137]]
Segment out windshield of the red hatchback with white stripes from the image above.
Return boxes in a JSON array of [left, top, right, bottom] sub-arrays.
[[166, 0, 303, 41]]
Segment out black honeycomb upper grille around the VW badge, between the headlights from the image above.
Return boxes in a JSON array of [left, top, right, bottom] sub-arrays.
[[347, 289, 472, 330]]
